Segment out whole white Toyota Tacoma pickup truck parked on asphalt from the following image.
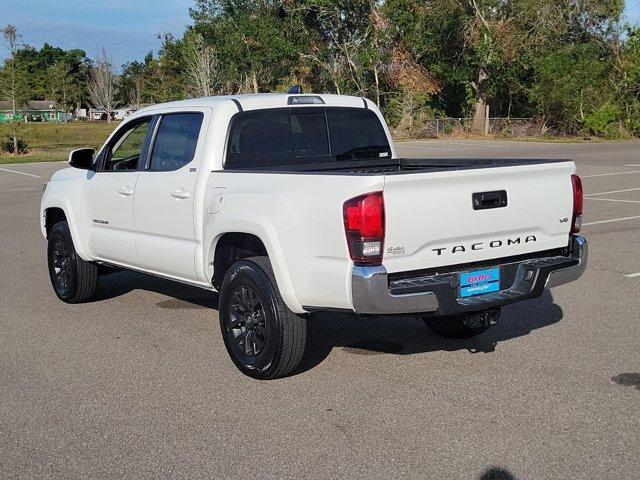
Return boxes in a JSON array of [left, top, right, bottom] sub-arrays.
[[41, 94, 587, 378]]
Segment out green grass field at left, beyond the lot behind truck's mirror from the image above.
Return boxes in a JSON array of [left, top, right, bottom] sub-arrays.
[[0, 122, 118, 164]]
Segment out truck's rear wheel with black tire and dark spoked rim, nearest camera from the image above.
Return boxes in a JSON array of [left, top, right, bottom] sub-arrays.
[[218, 257, 307, 380]]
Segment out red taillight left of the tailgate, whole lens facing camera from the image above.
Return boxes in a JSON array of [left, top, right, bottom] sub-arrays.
[[343, 192, 384, 265]]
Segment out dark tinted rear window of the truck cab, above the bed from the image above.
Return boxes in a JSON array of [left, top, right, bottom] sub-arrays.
[[225, 107, 391, 168]]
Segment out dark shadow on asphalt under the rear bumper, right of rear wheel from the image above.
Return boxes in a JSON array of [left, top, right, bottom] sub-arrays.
[[296, 290, 563, 373]]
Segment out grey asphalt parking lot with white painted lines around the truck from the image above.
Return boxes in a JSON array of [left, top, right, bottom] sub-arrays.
[[0, 140, 640, 480]]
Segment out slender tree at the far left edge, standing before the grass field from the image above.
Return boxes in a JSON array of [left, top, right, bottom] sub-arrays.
[[2, 24, 27, 154]]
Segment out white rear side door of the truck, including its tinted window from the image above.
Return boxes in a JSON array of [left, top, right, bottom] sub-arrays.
[[134, 108, 210, 281]]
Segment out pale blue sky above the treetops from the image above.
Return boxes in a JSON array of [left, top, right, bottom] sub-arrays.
[[0, 0, 640, 66]]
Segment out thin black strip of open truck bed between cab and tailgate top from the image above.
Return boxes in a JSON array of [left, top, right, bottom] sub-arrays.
[[218, 158, 570, 175]]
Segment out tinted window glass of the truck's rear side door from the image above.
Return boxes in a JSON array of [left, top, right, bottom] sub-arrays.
[[149, 113, 203, 172]]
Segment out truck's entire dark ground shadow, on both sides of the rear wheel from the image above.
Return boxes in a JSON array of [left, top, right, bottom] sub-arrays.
[[96, 271, 563, 375]]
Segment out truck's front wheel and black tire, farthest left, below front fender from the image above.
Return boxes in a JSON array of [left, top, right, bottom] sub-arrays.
[[47, 221, 98, 303]]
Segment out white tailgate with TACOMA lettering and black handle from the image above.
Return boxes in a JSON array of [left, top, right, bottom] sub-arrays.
[[383, 162, 575, 273]]
